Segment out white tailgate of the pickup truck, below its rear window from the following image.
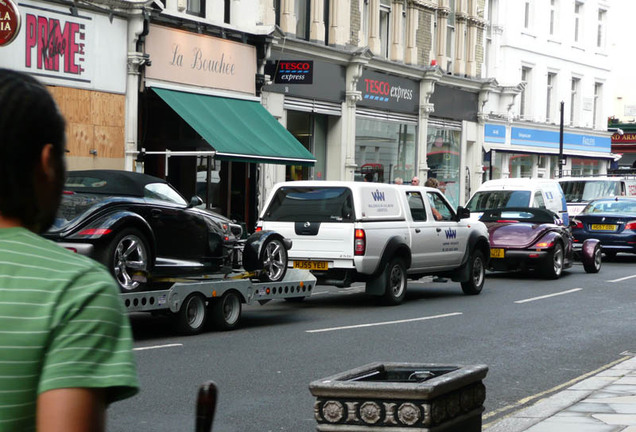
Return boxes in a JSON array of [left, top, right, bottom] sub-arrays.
[[263, 221, 354, 260]]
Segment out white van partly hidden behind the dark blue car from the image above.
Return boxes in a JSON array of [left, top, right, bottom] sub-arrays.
[[559, 177, 636, 216]]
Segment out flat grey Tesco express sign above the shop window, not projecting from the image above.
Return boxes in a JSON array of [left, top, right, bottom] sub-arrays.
[[357, 70, 420, 113]]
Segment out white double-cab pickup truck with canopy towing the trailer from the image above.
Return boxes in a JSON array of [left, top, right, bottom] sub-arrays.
[[257, 181, 490, 304]]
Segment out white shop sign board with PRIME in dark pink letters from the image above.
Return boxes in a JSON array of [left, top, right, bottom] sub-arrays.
[[0, 0, 127, 94]]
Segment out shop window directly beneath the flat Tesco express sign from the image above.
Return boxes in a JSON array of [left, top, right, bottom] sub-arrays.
[[355, 117, 417, 183]]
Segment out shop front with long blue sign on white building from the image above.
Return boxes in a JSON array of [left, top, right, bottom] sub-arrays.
[[484, 123, 614, 180]]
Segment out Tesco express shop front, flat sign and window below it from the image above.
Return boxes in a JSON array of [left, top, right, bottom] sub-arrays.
[[355, 69, 420, 183]]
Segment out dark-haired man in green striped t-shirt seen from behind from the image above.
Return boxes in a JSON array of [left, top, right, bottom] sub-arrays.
[[0, 69, 138, 432]]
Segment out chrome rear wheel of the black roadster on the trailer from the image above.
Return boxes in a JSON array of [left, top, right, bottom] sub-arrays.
[[113, 233, 148, 291]]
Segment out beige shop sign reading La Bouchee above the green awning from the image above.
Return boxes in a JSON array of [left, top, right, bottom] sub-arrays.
[[146, 25, 256, 95]]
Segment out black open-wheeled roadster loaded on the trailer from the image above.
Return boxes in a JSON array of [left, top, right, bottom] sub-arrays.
[[44, 170, 291, 292]]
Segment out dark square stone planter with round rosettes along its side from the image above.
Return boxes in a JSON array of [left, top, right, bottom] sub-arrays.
[[309, 363, 488, 432]]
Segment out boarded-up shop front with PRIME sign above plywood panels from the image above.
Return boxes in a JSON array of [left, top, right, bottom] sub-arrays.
[[0, 0, 127, 169]]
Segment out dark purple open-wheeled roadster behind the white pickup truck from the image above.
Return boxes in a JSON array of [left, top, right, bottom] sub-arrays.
[[480, 207, 601, 279]]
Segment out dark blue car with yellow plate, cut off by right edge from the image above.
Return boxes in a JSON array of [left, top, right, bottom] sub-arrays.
[[571, 197, 636, 258]]
